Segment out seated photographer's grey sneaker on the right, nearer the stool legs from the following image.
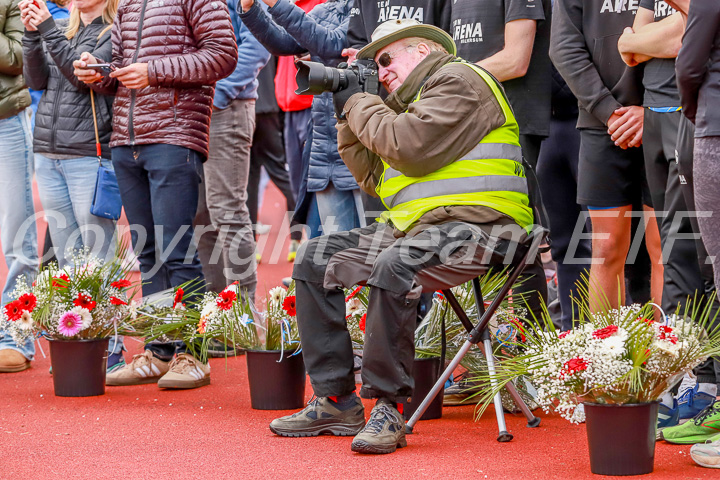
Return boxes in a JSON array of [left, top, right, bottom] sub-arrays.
[[351, 399, 407, 453]]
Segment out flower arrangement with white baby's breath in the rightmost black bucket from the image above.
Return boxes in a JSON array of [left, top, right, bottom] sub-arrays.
[[472, 296, 720, 423]]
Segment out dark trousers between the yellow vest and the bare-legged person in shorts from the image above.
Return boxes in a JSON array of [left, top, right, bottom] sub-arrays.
[[537, 118, 592, 330]]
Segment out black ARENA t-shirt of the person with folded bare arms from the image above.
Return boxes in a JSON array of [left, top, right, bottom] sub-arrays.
[[640, 0, 680, 108]]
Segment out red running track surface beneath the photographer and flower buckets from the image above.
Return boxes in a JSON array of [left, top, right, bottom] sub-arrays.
[[0, 182, 719, 480]]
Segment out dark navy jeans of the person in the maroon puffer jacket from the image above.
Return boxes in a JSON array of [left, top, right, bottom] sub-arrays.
[[112, 143, 204, 296]]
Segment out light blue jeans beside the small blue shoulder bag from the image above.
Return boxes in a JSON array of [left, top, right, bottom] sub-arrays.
[[35, 153, 115, 268]]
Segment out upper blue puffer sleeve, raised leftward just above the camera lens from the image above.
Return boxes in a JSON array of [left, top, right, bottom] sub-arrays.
[[268, 0, 349, 58]]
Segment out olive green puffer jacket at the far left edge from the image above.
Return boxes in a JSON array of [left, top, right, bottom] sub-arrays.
[[0, 0, 30, 119]]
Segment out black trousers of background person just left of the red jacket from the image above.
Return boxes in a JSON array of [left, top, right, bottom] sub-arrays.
[[247, 113, 302, 240]]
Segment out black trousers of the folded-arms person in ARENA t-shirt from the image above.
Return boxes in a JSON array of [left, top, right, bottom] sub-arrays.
[[643, 109, 703, 313]]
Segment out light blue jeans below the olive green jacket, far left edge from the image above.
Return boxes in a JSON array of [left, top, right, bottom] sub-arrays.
[[0, 110, 38, 360]]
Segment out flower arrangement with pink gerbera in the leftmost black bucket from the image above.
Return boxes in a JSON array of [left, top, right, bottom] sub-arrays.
[[0, 249, 140, 344]]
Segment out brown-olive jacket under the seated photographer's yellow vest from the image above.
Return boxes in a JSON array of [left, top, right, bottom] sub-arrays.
[[337, 52, 513, 236]]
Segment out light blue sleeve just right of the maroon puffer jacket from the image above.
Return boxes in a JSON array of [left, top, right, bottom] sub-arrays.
[[214, 0, 270, 108]]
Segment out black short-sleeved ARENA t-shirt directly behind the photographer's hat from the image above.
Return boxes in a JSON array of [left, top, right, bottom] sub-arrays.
[[448, 0, 552, 136]]
